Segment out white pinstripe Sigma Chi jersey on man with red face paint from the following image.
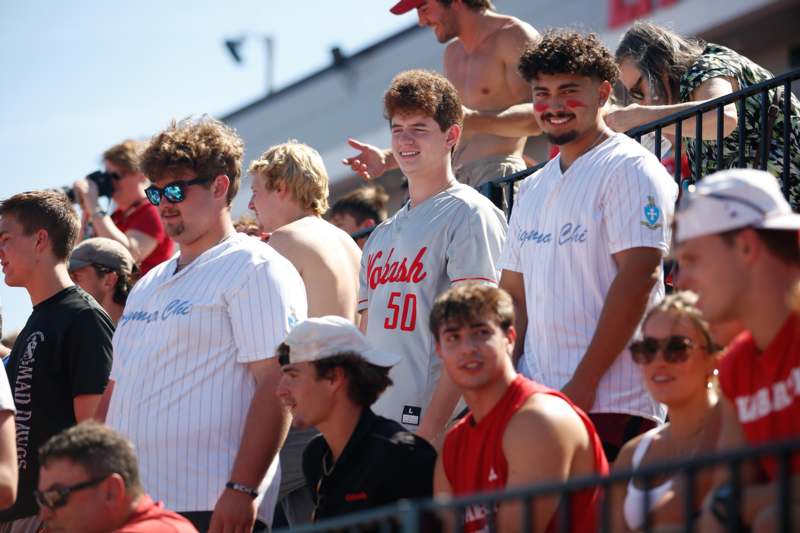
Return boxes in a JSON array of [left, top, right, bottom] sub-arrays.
[[498, 133, 678, 420]]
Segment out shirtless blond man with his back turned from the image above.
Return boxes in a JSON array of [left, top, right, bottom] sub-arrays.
[[249, 141, 361, 525]]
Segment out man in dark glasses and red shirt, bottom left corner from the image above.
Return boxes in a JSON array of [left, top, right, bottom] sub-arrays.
[[35, 422, 197, 533]]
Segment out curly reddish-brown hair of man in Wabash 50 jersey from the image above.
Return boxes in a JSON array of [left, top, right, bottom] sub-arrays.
[[383, 70, 464, 131]]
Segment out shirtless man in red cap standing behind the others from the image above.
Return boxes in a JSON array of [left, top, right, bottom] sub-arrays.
[[343, 0, 539, 187]]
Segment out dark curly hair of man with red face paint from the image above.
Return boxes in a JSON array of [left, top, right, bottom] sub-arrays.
[[519, 30, 619, 85]]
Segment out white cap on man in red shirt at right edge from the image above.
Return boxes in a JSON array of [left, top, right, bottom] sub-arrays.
[[675, 168, 800, 243]]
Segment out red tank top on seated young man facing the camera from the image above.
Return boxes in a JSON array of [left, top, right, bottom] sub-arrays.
[[442, 374, 608, 533]]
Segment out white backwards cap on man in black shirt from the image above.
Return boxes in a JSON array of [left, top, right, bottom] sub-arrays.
[[281, 315, 400, 367]]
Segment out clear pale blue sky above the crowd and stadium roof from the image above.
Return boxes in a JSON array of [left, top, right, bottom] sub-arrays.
[[0, 0, 416, 331]]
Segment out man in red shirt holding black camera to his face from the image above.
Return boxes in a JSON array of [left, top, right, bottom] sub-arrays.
[[74, 140, 174, 274]]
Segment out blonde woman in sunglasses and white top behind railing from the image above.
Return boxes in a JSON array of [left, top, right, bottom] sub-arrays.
[[612, 291, 720, 531]]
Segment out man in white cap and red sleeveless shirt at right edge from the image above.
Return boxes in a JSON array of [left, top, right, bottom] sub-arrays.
[[675, 169, 800, 531]]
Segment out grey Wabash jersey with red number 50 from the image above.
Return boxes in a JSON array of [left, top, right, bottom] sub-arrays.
[[358, 183, 507, 429]]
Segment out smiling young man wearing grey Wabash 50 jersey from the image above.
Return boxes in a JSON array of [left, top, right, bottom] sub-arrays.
[[358, 70, 506, 442]]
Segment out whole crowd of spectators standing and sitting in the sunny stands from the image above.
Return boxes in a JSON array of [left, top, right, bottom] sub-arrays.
[[0, 0, 800, 533]]
